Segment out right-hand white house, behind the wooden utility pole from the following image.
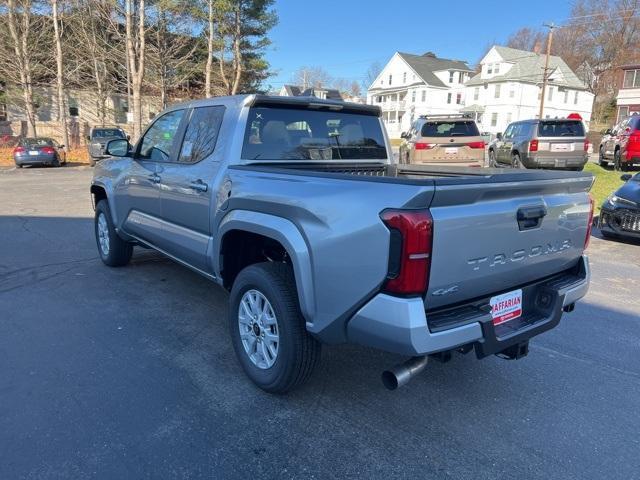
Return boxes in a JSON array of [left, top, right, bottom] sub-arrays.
[[462, 45, 594, 133]]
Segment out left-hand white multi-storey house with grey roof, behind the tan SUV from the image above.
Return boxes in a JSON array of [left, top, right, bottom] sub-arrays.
[[367, 52, 473, 138]]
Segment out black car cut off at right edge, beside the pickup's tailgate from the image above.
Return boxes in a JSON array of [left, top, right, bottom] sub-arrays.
[[598, 173, 640, 238]]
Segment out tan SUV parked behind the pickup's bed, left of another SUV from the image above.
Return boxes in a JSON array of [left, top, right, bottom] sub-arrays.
[[399, 115, 485, 167]]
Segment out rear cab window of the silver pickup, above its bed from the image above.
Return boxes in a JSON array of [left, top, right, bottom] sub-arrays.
[[242, 105, 387, 161]]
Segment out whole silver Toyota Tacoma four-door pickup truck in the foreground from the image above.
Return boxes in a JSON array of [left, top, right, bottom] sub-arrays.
[[91, 95, 593, 392]]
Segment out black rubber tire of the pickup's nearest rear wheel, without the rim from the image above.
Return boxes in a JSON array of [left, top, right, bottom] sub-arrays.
[[229, 262, 321, 393]]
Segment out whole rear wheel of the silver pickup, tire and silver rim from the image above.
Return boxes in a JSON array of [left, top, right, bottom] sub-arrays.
[[229, 262, 321, 393]]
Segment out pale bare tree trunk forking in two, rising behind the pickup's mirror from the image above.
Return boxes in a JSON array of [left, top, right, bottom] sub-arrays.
[[125, 0, 146, 140]]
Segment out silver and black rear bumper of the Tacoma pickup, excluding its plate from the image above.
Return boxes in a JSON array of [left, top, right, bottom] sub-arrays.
[[347, 256, 590, 357]]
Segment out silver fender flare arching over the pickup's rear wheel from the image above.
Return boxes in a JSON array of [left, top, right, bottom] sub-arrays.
[[212, 210, 315, 322]]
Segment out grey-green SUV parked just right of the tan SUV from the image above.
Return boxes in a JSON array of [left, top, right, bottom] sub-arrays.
[[489, 118, 589, 171]]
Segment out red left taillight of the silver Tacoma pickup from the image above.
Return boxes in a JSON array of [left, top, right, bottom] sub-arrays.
[[380, 210, 433, 295]]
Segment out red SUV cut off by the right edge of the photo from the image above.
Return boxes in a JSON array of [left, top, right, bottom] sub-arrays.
[[598, 115, 640, 171]]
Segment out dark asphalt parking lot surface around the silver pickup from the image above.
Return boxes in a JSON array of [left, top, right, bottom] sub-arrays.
[[0, 167, 640, 479]]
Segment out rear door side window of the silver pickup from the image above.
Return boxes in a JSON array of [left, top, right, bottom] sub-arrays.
[[178, 106, 224, 163]]
